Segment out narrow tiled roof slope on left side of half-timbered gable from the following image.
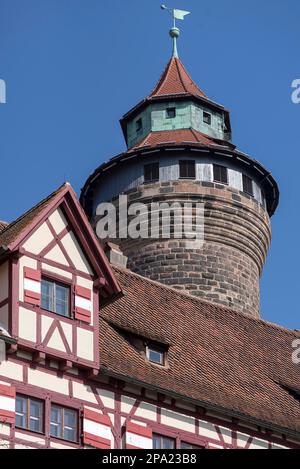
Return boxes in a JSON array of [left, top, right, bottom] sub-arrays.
[[0, 184, 66, 247]]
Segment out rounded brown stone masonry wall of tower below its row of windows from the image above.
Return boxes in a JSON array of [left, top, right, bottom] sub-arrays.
[[95, 181, 271, 317]]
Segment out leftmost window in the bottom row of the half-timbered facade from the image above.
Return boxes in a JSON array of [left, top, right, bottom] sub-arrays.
[[16, 395, 44, 433]]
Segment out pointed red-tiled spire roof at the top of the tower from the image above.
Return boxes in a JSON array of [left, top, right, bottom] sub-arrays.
[[148, 57, 206, 98]]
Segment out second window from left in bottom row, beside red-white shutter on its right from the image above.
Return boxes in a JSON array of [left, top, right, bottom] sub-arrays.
[[50, 404, 78, 442]]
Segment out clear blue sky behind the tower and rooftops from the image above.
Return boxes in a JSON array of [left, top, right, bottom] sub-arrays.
[[0, 0, 300, 328]]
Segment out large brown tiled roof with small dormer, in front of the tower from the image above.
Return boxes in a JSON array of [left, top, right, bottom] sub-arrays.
[[100, 269, 300, 432]]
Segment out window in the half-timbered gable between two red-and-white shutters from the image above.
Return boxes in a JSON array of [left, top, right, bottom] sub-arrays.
[[42, 279, 70, 317]]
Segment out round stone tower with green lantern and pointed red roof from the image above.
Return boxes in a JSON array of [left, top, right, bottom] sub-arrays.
[[81, 28, 279, 317]]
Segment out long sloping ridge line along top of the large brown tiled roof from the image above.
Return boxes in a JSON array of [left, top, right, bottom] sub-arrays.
[[113, 266, 300, 337]]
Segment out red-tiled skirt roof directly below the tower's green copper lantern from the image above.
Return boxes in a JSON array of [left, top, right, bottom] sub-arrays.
[[130, 129, 234, 151]]
